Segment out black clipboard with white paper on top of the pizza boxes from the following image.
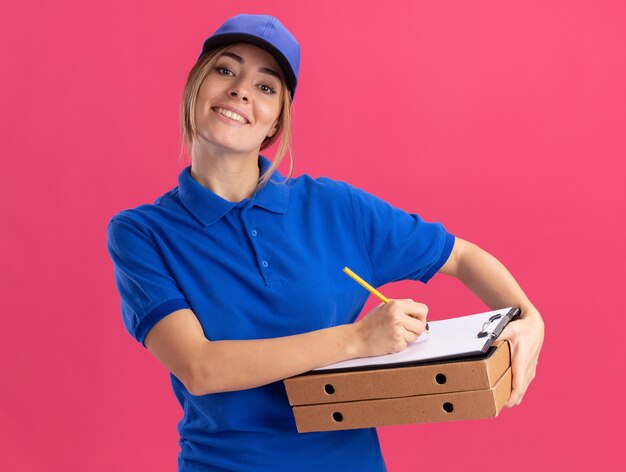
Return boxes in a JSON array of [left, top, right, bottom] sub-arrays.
[[309, 307, 521, 374]]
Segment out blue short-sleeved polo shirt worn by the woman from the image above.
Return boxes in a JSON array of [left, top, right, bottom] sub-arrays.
[[107, 156, 454, 472]]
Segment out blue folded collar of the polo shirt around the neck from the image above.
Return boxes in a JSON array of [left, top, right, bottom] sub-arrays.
[[178, 154, 289, 226]]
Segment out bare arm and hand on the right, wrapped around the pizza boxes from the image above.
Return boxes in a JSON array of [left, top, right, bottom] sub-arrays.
[[439, 238, 544, 407]]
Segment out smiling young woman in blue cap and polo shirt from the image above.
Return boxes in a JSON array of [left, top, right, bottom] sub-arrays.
[[107, 15, 543, 471]]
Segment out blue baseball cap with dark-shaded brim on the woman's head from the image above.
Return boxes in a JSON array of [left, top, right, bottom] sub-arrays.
[[198, 13, 300, 100]]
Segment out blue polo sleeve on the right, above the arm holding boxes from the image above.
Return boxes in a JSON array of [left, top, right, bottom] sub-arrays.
[[350, 186, 454, 287]]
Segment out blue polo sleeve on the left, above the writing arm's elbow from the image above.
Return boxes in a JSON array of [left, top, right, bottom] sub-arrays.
[[107, 216, 190, 347]]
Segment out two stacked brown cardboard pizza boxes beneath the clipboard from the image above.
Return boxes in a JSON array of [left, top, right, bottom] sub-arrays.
[[284, 341, 511, 433]]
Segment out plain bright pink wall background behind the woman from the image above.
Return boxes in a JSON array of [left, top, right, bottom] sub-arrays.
[[0, 0, 626, 472]]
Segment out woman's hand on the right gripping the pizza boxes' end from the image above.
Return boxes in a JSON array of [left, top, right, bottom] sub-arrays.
[[498, 307, 544, 408]]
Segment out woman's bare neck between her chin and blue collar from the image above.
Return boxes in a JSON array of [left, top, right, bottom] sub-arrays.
[[191, 149, 260, 202]]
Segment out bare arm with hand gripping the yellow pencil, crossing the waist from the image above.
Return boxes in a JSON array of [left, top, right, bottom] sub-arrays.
[[145, 299, 427, 395]]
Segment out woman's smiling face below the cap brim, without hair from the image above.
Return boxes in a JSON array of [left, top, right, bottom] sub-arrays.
[[195, 43, 283, 155]]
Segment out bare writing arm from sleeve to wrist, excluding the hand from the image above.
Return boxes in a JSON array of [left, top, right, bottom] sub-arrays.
[[145, 309, 355, 395]]
